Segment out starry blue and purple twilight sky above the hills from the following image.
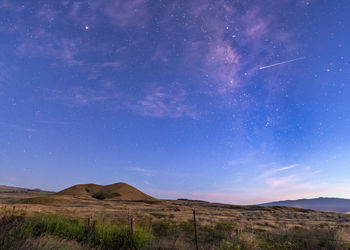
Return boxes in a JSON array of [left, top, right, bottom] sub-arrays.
[[0, 0, 350, 204]]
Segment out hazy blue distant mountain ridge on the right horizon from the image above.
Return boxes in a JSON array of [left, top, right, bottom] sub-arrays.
[[259, 197, 350, 213]]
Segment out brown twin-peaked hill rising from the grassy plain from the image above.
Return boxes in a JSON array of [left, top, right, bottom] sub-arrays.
[[55, 182, 157, 201]]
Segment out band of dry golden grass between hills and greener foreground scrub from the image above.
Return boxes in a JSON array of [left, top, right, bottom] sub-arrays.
[[0, 191, 350, 230]]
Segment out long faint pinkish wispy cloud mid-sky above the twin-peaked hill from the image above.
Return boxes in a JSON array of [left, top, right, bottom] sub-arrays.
[[49, 83, 197, 119]]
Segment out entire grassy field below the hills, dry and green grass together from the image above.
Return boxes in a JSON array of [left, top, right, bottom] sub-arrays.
[[0, 193, 350, 249]]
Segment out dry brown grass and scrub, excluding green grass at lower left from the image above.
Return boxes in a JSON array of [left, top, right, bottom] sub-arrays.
[[0, 188, 350, 249]]
